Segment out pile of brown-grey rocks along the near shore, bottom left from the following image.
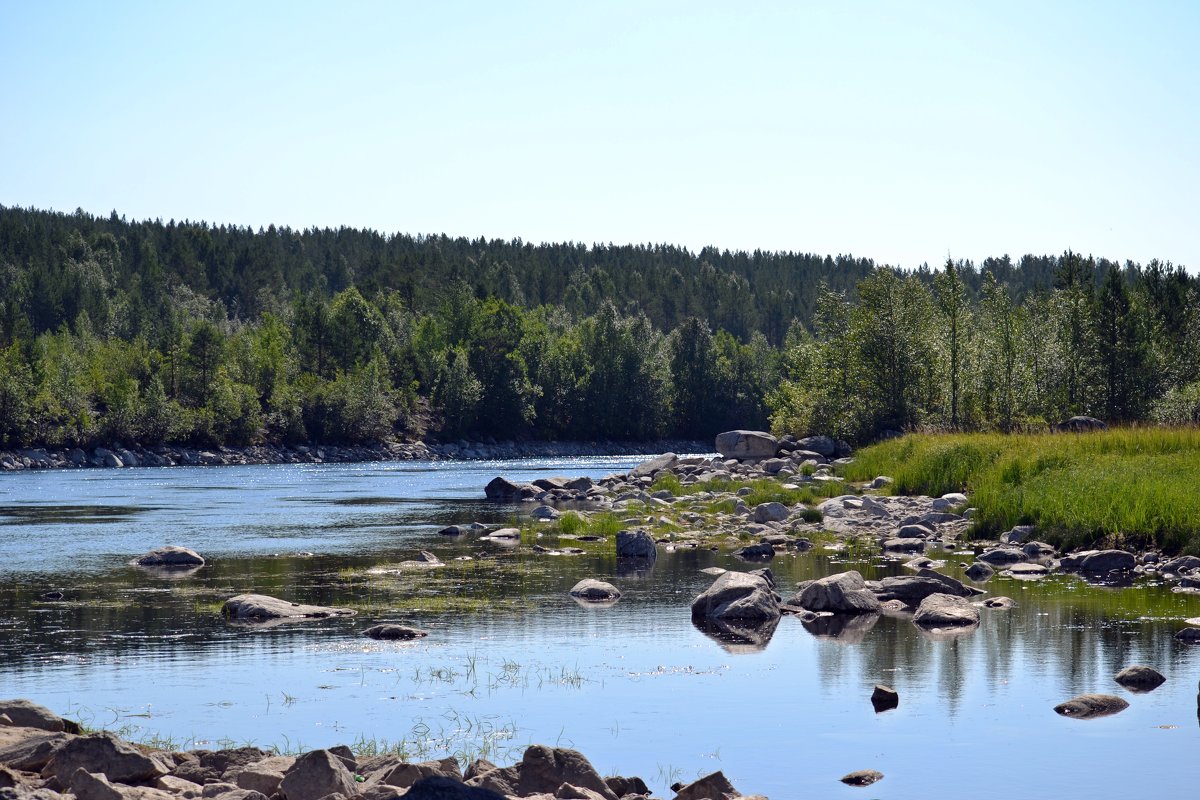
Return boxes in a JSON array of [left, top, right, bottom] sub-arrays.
[[0, 699, 766, 800]]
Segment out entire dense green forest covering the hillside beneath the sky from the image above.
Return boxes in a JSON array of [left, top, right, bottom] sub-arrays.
[[0, 206, 1200, 446]]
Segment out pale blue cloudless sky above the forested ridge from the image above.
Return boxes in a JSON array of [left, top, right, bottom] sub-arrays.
[[0, 0, 1200, 271]]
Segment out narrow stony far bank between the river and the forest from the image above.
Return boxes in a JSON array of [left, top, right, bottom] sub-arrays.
[[0, 440, 712, 471]]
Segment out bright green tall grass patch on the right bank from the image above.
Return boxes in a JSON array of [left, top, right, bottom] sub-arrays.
[[845, 428, 1200, 555]]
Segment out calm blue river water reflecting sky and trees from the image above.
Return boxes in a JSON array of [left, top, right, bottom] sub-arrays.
[[0, 457, 1200, 800]]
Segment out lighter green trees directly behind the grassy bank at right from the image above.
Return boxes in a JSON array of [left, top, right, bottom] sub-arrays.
[[769, 252, 1200, 440]]
